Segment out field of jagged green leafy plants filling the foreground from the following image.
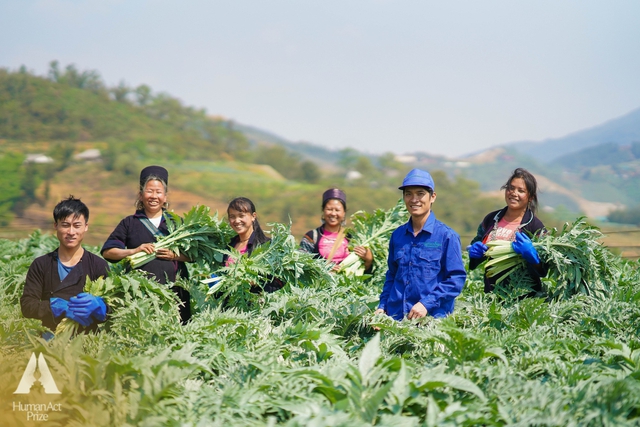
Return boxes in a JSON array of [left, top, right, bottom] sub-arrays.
[[0, 226, 640, 427]]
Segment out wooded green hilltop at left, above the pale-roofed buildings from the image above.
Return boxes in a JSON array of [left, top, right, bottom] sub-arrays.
[[0, 61, 324, 177]]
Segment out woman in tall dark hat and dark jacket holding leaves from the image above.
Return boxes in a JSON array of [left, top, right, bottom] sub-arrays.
[[100, 166, 191, 323]]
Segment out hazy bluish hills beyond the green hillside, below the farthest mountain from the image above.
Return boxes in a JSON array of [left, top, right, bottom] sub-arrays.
[[238, 115, 640, 219]]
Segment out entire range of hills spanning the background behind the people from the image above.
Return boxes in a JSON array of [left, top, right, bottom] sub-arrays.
[[0, 62, 640, 231]]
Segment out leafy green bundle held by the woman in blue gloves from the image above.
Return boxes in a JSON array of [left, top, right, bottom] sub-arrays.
[[485, 217, 621, 299]]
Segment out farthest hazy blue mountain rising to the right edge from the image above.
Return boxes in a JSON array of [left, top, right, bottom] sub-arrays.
[[507, 108, 640, 163]]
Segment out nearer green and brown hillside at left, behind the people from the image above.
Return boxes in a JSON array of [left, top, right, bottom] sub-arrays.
[[0, 62, 501, 243]]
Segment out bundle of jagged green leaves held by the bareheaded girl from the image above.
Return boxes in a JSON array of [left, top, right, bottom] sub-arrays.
[[203, 223, 334, 307]]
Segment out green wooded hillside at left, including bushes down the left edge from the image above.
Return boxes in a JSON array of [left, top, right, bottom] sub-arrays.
[[0, 61, 336, 224]]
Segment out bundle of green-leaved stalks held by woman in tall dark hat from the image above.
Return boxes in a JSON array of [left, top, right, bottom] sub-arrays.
[[127, 205, 233, 268]]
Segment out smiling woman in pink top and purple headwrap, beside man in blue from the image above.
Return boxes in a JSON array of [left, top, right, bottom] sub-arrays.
[[300, 188, 373, 272]]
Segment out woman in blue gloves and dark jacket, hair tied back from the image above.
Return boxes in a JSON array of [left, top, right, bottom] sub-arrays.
[[467, 168, 547, 292]]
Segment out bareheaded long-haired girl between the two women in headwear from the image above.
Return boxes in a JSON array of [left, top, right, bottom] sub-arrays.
[[222, 197, 284, 293]]
